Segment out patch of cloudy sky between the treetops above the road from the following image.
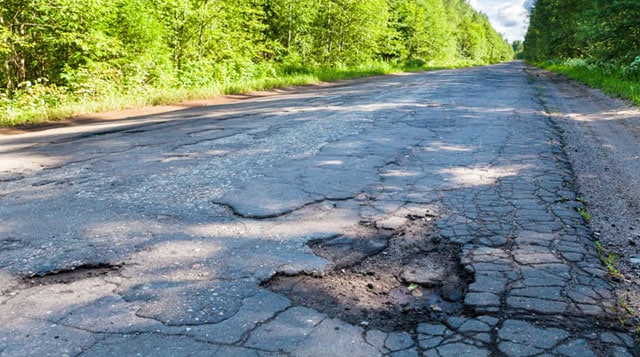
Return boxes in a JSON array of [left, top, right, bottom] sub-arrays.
[[469, 0, 535, 42]]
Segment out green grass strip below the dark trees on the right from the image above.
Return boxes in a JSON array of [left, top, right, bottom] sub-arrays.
[[533, 60, 640, 105]]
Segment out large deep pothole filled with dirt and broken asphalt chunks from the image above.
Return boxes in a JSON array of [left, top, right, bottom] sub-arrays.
[[263, 217, 473, 331]]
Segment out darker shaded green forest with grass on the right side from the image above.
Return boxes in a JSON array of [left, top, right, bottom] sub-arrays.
[[524, 0, 640, 104]]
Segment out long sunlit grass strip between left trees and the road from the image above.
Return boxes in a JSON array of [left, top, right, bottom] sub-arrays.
[[0, 61, 475, 127]]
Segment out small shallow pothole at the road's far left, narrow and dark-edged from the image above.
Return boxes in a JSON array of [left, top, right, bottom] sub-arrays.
[[22, 264, 122, 287]]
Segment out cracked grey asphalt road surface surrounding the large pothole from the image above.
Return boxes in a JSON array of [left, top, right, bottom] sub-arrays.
[[0, 62, 638, 357]]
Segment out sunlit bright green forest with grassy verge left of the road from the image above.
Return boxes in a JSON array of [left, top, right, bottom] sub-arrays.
[[0, 0, 513, 125]]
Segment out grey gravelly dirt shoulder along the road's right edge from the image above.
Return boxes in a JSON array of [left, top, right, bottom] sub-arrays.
[[526, 67, 640, 325]]
